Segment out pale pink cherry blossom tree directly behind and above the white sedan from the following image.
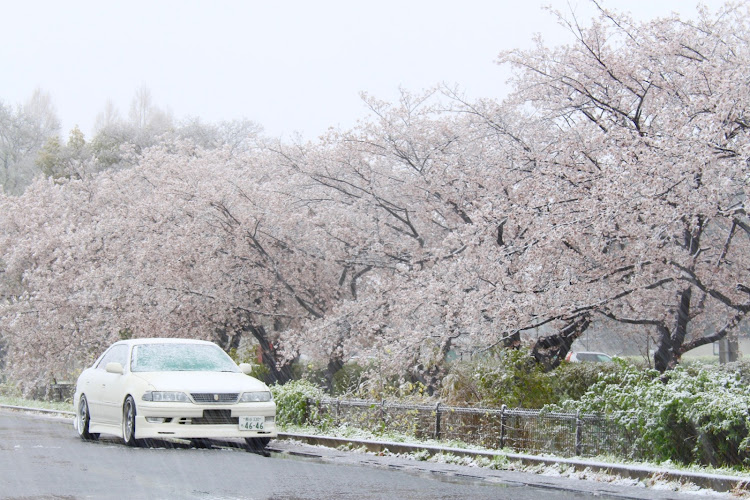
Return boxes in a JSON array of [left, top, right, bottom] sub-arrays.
[[0, 137, 356, 385]]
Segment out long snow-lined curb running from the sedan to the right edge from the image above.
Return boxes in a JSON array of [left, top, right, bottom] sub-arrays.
[[277, 432, 750, 492]]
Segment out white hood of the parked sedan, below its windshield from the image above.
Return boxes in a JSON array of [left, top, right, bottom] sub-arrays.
[[133, 372, 268, 393]]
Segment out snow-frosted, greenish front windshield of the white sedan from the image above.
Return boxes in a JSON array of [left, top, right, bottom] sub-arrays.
[[130, 343, 239, 372]]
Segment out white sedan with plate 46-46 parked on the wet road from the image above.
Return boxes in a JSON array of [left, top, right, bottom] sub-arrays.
[[73, 339, 276, 449]]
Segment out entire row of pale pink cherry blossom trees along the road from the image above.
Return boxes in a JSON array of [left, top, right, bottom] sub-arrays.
[[0, 0, 750, 394]]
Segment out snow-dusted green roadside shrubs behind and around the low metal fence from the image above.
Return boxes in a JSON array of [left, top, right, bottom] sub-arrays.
[[273, 350, 750, 472]]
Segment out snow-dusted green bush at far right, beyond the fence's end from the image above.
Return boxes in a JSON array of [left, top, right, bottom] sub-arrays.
[[554, 364, 750, 466]]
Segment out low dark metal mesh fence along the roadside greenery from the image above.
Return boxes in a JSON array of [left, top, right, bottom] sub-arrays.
[[308, 398, 641, 458]]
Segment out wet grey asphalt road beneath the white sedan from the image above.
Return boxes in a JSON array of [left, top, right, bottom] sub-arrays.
[[0, 410, 732, 500]]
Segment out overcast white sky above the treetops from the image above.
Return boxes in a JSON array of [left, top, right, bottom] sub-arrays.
[[0, 0, 723, 139]]
